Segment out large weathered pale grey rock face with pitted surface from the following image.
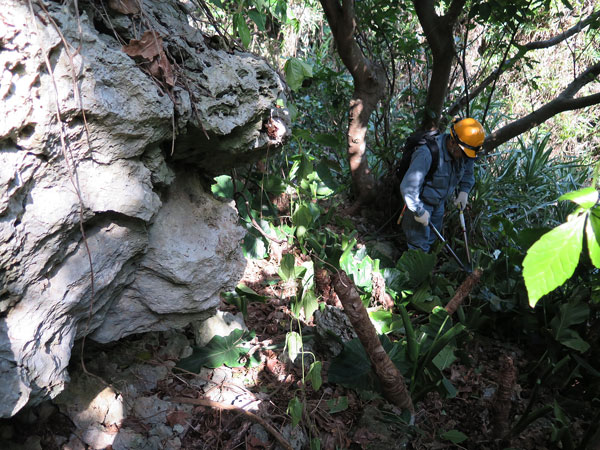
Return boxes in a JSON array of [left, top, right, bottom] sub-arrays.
[[0, 0, 289, 417]]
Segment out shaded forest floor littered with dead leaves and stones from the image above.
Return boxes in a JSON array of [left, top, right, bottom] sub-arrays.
[[0, 220, 593, 450]]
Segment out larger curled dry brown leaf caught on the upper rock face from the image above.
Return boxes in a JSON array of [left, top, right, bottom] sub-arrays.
[[123, 30, 175, 87]]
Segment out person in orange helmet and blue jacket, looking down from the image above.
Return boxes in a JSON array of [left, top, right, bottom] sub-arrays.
[[400, 118, 485, 252]]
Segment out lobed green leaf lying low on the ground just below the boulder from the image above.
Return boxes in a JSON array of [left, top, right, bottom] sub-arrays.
[[177, 329, 254, 373]]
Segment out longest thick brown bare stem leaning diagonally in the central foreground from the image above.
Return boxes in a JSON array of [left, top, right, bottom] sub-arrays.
[[333, 272, 414, 414]]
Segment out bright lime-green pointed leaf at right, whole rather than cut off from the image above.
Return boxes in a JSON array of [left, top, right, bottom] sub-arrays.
[[523, 214, 586, 307]]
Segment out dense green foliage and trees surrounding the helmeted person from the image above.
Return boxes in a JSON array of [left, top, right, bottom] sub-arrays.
[[183, 0, 600, 449]]
